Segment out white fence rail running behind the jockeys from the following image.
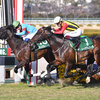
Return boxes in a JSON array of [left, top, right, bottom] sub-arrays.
[[24, 18, 100, 25]]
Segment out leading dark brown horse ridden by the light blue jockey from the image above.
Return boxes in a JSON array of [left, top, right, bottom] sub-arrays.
[[0, 25, 55, 78]]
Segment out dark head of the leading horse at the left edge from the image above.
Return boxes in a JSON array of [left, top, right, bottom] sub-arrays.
[[0, 25, 15, 39]]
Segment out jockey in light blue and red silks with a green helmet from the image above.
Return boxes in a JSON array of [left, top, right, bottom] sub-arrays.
[[13, 21, 37, 42]]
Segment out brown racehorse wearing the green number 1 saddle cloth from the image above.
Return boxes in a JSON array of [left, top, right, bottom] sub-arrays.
[[33, 27, 100, 81]]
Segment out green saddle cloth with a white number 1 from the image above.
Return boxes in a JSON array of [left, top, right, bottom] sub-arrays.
[[69, 36, 94, 51]]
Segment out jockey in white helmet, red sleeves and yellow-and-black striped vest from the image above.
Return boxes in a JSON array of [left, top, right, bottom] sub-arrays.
[[53, 16, 82, 45]]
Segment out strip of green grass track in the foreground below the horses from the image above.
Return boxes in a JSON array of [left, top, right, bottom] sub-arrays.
[[0, 83, 100, 100]]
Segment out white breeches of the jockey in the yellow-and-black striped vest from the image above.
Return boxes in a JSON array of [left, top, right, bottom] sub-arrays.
[[64, 28, 82, 37]]
